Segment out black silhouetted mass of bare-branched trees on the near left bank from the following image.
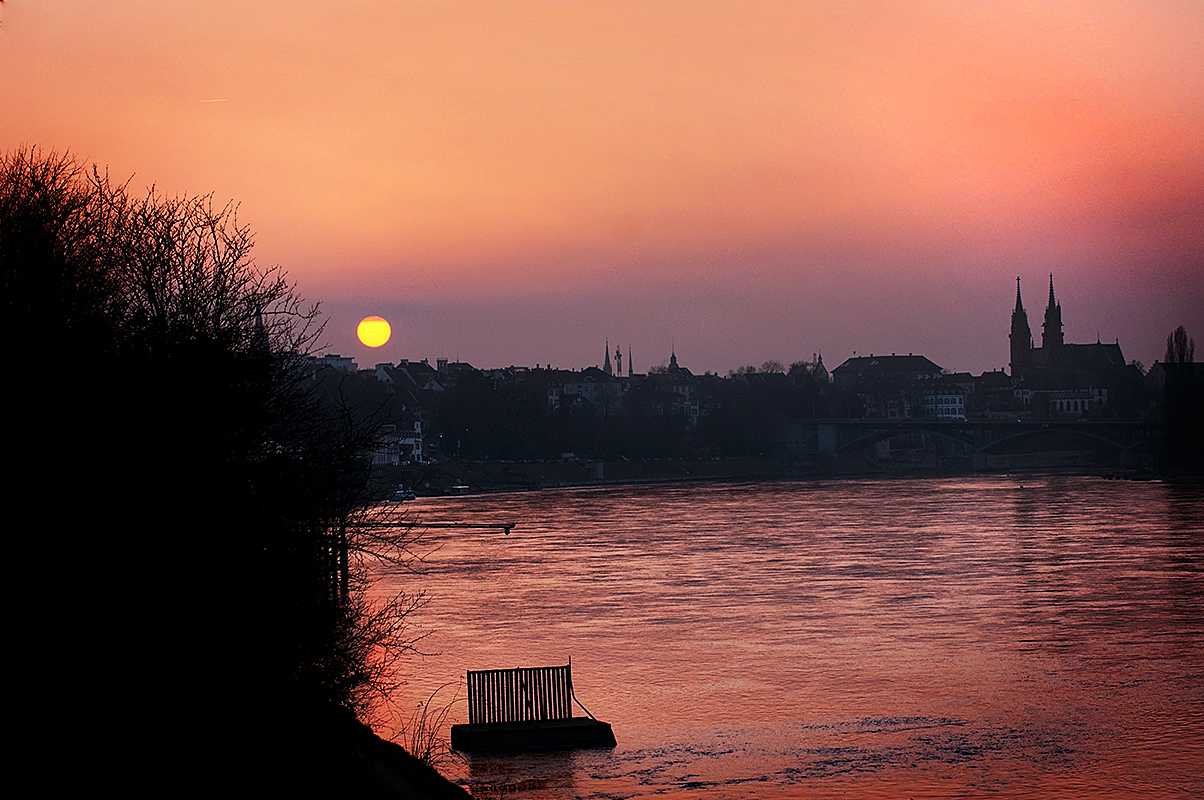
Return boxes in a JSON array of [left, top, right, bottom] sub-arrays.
[[0, 149, 435, 794]]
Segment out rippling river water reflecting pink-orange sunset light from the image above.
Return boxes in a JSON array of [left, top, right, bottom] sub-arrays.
[[377, 476, 1204, 799]]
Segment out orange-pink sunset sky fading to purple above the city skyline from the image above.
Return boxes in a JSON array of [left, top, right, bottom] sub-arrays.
[[0, 0, 1204, 373]]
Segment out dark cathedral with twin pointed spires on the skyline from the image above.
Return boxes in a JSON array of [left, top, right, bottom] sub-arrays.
[[1010, 275, 1140, 414]]
